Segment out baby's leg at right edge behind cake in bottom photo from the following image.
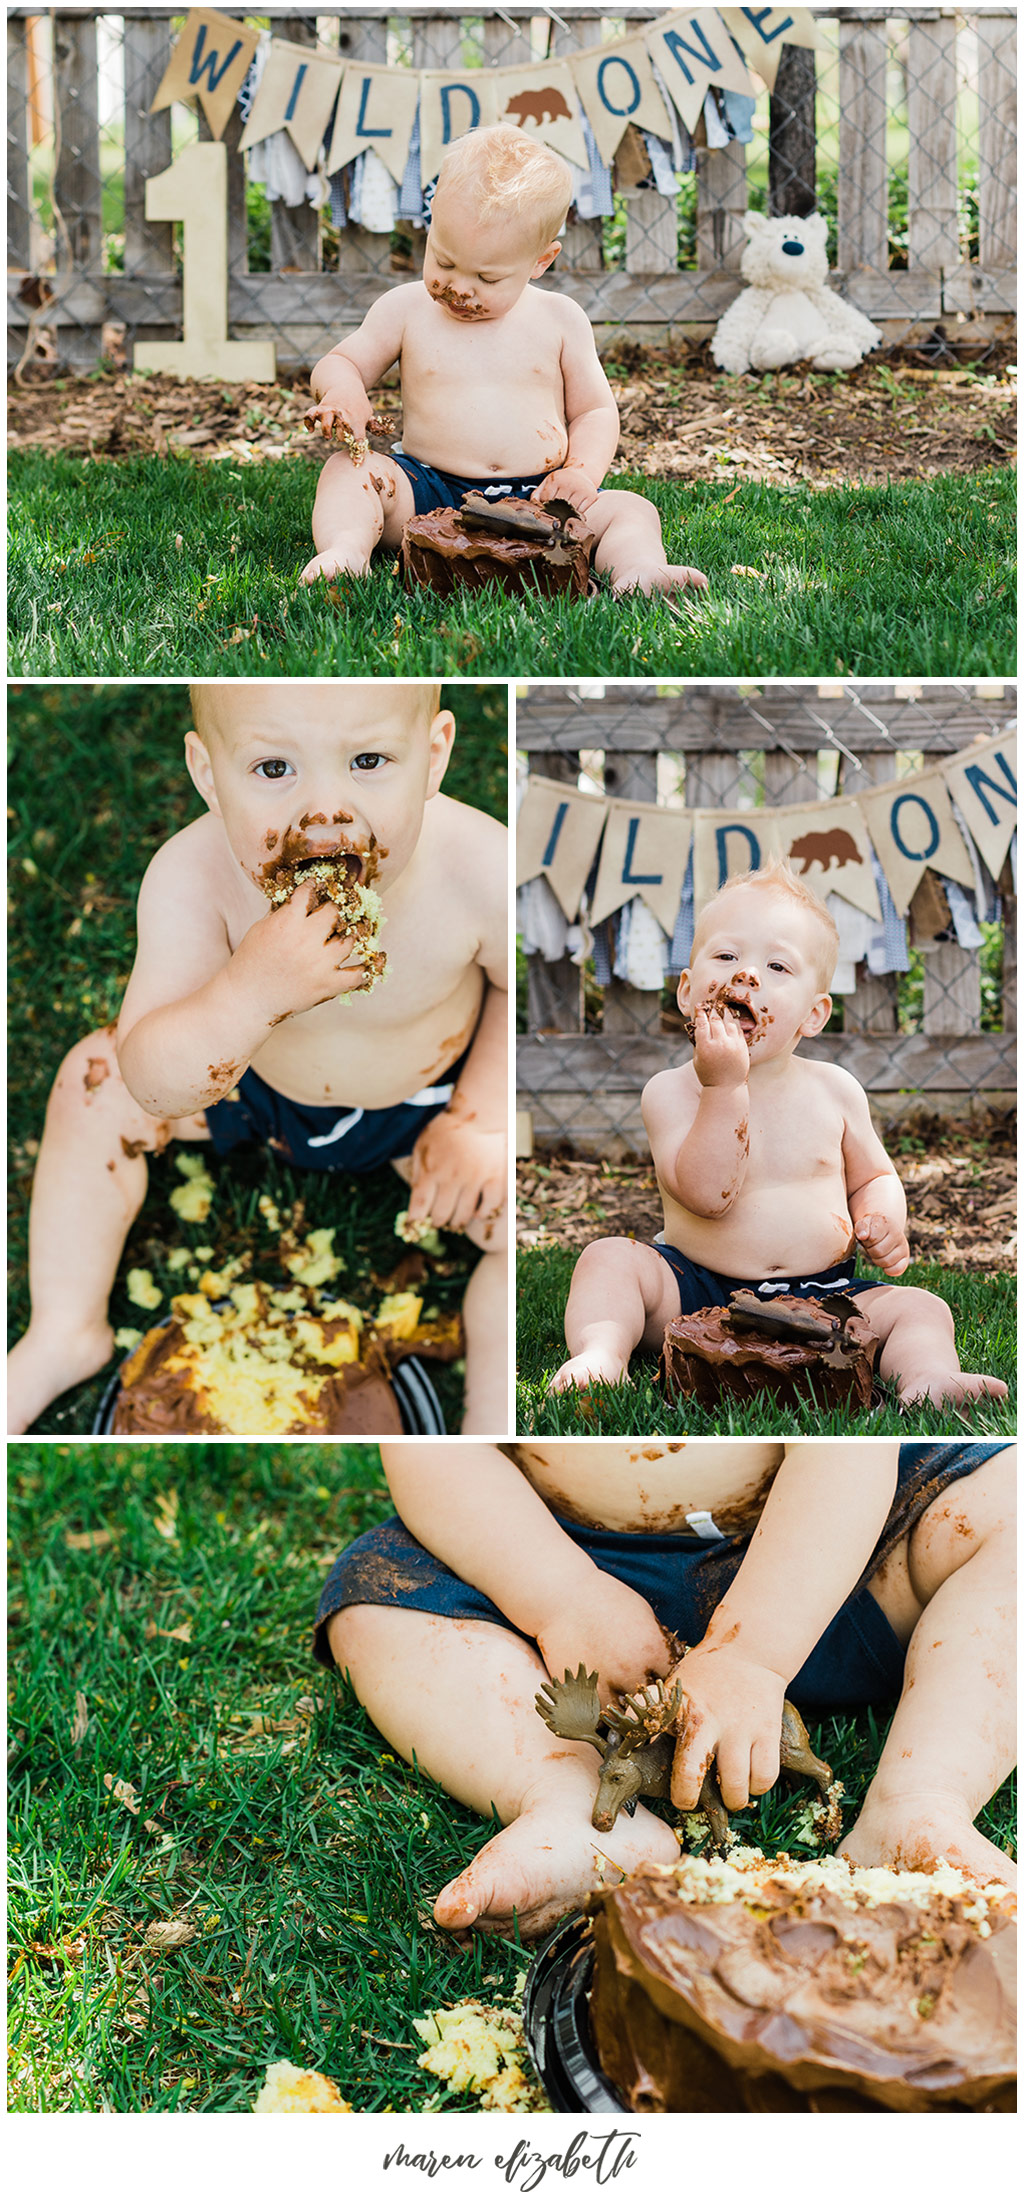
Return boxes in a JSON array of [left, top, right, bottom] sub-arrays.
[[843, 1449, 1015, 1886]]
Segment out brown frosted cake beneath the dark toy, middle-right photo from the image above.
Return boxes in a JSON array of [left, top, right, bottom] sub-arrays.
[[660, 1297, 878, 1409]]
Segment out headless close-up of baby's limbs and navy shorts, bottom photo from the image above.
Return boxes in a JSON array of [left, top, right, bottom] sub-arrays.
[[316, 1440, 1015, 1937]]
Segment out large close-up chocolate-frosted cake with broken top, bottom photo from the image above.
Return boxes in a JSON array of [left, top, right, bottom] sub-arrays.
[[587, 1849, 1015, 2110]]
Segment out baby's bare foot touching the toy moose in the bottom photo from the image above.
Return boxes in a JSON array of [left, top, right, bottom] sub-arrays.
[[435, 1794, 680, 1940]]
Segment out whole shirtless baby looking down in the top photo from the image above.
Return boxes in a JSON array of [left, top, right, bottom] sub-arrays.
[[302, 124, 706, 594]]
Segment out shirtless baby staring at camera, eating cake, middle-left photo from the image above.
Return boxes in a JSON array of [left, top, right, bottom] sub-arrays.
[[9, 683, 508, 1434]]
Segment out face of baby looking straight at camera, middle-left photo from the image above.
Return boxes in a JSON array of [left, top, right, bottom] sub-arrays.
[[185, 683, 455, 892]]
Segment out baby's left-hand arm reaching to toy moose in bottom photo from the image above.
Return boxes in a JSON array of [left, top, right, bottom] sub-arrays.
[[380, 1442, 669, 1701]]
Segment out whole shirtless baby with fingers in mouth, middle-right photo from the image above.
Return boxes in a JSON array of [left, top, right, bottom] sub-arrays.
[[552, 864, 1006, 1405]]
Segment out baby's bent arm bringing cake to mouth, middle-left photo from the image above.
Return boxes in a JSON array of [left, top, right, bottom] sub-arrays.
[[117, 824, 364, 1120]]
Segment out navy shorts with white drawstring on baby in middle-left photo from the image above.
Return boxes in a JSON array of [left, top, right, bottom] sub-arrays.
[[205, 1051, 468, 1173]]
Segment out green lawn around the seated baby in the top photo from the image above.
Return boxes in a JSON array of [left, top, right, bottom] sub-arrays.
[[9, 448, 1015, 680]]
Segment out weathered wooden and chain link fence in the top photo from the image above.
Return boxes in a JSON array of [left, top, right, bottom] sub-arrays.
[[7, 4, 1015, 373]]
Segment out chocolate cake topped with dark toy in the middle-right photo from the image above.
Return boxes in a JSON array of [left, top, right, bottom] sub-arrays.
[[660, 1294, 878, 1412]]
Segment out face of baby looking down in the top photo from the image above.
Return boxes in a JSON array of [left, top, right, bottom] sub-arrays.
[[424, 190, 558, 323]]
